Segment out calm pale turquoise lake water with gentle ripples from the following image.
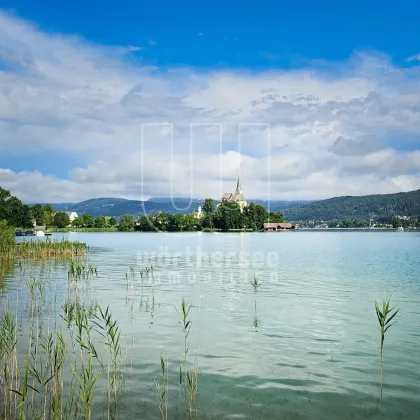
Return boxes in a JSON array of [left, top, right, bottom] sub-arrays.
[[0, 232, 420, 420]]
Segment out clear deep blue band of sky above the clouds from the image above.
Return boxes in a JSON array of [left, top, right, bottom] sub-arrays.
[[1, 0, 420, 69]]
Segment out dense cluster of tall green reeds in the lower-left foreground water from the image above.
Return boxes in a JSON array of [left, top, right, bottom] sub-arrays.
[[0, 261, 124, 420]]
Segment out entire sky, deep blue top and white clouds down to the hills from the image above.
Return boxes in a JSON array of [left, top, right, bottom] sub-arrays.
[[0, 0, 420, 202]]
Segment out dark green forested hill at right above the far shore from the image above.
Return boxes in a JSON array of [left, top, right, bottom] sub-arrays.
[[283, 190, 420, 221]]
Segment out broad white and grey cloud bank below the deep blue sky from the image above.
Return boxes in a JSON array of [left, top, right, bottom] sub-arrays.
[[0, 13, 420, 201]]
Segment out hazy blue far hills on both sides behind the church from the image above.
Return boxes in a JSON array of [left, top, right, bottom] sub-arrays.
[[47, 197, 308, 217]]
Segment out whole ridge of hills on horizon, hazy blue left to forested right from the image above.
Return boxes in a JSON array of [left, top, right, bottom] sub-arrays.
[[30, 190, 420, 221]]
